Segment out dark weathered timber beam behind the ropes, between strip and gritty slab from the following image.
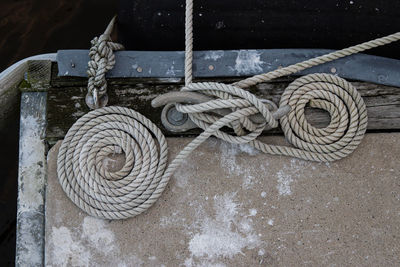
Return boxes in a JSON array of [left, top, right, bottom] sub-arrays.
[[47, 70, 400, 144]]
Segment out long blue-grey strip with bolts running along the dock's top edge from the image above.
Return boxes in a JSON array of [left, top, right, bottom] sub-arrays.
[[57, 49, 400, 87]]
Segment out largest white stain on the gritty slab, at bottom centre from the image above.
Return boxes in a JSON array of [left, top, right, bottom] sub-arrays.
[[185, 193, 261, 266]]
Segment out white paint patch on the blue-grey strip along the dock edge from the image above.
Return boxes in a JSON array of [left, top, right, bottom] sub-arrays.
[[233, 50, 265, 74]]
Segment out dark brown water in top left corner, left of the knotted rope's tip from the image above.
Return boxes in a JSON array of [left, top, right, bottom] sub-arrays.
[[0, 0, 118, 71]]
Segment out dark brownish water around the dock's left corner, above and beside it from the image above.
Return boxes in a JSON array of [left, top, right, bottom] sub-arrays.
[[0, 0, 117, 266]]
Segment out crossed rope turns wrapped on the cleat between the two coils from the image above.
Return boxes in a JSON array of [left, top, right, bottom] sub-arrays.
[[175, 82, 288, 143]]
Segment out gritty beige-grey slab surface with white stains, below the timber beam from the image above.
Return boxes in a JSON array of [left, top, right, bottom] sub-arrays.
[[45, 134, 400, 266]]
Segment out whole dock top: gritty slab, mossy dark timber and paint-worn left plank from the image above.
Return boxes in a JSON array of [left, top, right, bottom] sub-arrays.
[[16, 58, 400, 266]]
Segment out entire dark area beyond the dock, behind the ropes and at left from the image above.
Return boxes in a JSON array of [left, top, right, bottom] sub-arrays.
[[0, 0, 400, 266]]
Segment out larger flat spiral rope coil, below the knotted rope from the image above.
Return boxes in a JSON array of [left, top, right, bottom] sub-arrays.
[[57, 106, 168, 219]]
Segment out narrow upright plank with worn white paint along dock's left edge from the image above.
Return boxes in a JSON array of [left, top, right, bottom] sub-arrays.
[[15, 92, 47, 266]]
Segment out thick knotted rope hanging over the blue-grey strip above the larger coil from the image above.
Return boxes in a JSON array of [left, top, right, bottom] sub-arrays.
[[87, 17, 124, 108]]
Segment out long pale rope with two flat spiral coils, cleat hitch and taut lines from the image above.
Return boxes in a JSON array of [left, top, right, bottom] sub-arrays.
[[57, 0, 400, 219]]
